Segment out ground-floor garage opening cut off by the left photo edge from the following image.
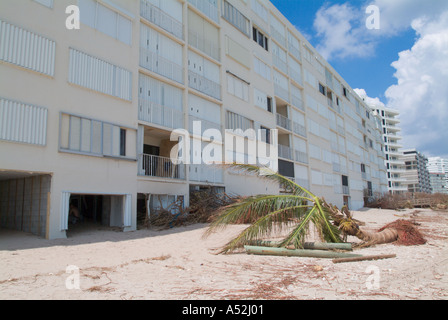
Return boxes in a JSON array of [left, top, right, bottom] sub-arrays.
[[0, 170, 51, 237]]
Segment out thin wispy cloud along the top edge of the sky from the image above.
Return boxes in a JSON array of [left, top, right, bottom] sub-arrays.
[[314, 0, 448, 60]]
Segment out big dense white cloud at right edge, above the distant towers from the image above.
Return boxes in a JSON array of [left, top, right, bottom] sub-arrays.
[[386, 11, 448, 156]]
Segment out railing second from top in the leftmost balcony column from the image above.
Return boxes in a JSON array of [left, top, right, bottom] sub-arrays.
[[140, 48, 184, 83]]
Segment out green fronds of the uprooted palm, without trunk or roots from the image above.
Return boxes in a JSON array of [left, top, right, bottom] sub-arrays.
[[204, 164, 342, 253]]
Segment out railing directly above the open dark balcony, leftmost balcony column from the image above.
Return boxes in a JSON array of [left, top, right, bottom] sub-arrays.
[[138, 98, 184, 129]]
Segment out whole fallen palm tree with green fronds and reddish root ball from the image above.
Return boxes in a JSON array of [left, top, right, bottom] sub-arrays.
[[205, 164, 425, 253]]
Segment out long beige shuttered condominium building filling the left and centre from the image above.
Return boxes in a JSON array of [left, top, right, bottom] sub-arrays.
[[0, 0, 387, 239]]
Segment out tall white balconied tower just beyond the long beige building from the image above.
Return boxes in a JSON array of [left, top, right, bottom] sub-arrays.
[[358, 91, 408, 194]]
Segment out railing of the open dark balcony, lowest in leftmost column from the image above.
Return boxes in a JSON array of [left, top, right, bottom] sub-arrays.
[[138, 154, 186, 180]]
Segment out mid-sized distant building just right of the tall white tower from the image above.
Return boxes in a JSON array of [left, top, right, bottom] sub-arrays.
[[400, 149, 432, 193]]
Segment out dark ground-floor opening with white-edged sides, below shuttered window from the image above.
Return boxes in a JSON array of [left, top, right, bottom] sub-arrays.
[[63, 193, 132, 237]]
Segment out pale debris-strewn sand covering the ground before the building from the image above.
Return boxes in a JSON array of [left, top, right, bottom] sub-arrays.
[[0, 210, 448, 300]]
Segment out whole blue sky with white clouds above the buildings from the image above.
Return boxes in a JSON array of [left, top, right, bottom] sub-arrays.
[[271, 0, 448, 158]]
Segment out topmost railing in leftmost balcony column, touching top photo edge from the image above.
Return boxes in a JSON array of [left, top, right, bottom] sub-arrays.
[[140, 0, 184, 40]]
